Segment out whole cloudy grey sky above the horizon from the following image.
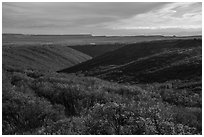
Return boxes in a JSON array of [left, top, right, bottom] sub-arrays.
[[2, 2, 202, 35]]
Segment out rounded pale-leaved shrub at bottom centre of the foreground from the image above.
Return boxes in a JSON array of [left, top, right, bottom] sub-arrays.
[[85, 102, 145, 135]]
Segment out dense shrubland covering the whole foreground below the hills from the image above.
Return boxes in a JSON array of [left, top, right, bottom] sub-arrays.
[[2, 70, 202, 135]]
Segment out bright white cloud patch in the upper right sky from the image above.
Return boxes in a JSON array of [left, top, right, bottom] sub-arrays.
[[106, 3, 202, 30]]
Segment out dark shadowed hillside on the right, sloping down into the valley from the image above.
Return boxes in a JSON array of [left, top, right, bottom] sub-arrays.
[[60, 39, 202, 82]]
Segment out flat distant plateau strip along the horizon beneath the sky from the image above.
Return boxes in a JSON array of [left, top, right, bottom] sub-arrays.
[[2, 34, 201, 46]]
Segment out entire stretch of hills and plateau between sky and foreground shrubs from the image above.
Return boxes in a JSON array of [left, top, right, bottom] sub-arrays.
[[2, 34, 202, 83]]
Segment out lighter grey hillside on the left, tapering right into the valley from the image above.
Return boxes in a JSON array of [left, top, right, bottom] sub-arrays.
[[2, 45, 91, 71]]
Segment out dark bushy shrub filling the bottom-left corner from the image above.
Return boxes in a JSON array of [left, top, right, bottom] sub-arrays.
[[2, 90, 63, 134]]
